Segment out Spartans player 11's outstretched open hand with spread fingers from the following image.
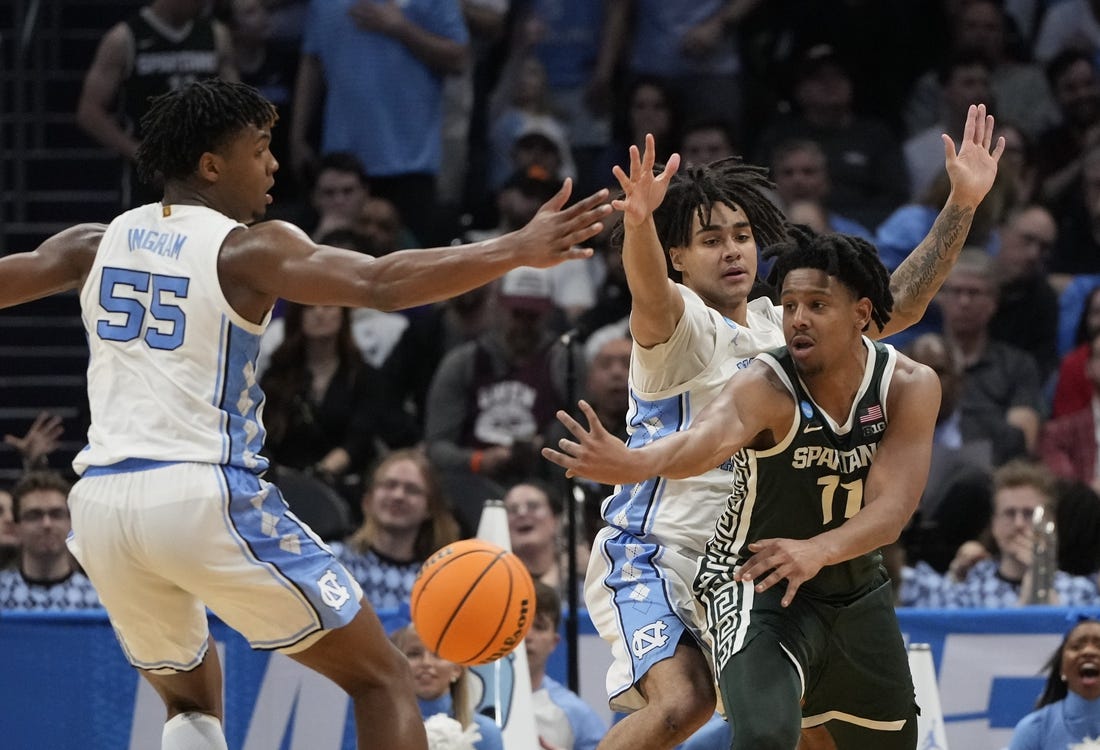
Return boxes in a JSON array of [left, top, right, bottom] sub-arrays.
[[542, 400, 650, 484]]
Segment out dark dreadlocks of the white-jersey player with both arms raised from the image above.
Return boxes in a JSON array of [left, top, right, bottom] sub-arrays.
[[612, 156, 790, 277]]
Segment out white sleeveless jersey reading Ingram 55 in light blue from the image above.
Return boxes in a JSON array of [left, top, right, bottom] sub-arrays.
[[73, 203, 270, 474]]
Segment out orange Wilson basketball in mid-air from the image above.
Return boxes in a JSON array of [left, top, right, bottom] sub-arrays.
[[409, 539, 535, 666]]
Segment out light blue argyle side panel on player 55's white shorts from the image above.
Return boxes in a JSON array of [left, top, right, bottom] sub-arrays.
[[221, 466, 360, 650]]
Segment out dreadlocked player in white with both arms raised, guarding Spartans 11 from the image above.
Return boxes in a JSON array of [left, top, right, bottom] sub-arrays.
[[585, 104, 1004, 750]]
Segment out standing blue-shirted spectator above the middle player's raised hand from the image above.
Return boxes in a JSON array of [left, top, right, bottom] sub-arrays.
[[603, 0, 761, 134]]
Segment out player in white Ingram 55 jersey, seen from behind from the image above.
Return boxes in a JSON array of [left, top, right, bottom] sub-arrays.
[[0, 79, 611, 750]]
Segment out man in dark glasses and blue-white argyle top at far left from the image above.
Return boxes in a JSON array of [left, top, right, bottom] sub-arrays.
[[0, 471, 102, 611]]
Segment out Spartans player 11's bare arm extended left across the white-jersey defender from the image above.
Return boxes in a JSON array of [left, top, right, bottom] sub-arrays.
[[542, 364, 794, 484]]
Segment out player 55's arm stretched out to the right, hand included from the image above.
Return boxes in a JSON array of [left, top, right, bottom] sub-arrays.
[[219, 180, 611, 310]]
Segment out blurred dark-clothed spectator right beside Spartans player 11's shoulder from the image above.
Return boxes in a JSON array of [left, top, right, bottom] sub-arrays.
[[903, 333, 1001, 567]]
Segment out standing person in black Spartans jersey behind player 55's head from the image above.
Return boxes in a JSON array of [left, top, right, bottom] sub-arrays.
[[76, 0, 238, 208]]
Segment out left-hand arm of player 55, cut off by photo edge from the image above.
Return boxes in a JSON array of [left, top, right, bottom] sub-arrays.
[[0, 224, 107, 308]]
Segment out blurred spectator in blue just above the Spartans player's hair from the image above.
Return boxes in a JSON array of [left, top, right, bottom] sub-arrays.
[[771, 140, 871, 236]]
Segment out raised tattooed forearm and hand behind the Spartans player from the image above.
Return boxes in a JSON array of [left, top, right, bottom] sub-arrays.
[[868, 104, 1004, 338]]
